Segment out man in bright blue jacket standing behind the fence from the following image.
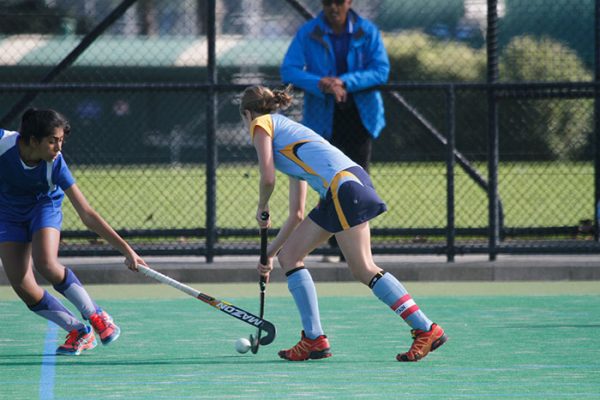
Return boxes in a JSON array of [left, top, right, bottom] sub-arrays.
[[280, 0, 390, 259]]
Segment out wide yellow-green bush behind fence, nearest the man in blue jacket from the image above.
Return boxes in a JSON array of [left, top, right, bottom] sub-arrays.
[[380, 31, 487, 161]]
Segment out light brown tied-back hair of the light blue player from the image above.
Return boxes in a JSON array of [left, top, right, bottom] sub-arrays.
[[240, 85, 292, 116]]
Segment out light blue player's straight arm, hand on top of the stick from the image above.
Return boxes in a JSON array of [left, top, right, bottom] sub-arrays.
[[253, 126, 275, 228]]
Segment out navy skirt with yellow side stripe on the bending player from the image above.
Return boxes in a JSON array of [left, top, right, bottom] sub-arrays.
[[308, 167, 387, 233]]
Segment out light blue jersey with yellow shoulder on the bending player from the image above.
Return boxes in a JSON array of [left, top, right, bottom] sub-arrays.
[[250, 114, 358, 199]]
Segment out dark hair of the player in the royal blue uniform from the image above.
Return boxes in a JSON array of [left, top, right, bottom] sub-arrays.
[[19, 108, 71, 143]]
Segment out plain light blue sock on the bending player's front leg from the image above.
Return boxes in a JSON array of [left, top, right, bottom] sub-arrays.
[[288, 268, 323, 339]]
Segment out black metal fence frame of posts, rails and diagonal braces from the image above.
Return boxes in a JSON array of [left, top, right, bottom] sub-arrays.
[[0, 0, 600, 262]]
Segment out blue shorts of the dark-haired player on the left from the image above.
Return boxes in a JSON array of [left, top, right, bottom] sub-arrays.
[[0, 200, 63, 243]]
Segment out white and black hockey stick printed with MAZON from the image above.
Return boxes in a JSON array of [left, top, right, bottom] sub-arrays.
[[137, 265, 277, 346]]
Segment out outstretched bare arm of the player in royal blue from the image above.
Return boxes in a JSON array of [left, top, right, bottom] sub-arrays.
[[65, 184, 146, 270]]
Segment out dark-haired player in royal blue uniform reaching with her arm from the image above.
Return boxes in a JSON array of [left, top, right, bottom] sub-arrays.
[[0, 109, 145, 355]]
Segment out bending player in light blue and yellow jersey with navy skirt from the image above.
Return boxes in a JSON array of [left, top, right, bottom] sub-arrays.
[[240, 86, 447, 361]]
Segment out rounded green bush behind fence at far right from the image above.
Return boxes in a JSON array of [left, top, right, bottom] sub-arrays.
[[499, 36, 593, 159]]
